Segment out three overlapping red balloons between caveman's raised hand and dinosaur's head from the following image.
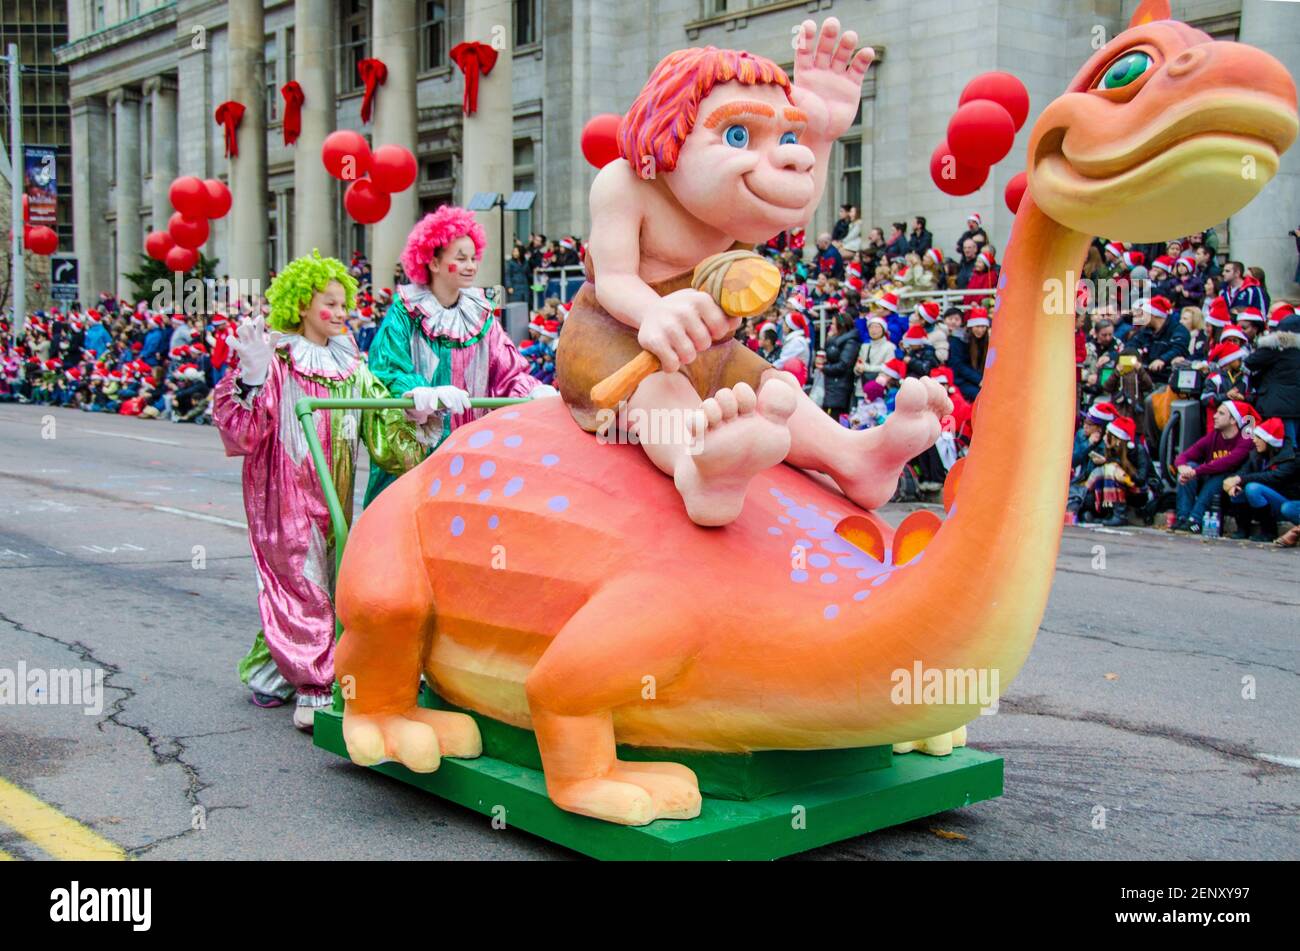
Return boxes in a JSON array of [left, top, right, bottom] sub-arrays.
[[930, 73, 1030, 203]]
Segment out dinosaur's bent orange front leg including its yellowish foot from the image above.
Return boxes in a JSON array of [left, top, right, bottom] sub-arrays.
[[525, 578, 701, 825]]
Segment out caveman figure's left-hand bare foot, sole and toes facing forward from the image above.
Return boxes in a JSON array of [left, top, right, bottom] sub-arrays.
[[673, 381, 796, 525]]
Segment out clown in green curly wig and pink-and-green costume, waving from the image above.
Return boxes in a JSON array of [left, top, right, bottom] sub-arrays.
[[213, 252, 425, 730]]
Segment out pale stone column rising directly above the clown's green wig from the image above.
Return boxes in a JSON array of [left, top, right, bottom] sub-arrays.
[[289, 0, 335, 260]]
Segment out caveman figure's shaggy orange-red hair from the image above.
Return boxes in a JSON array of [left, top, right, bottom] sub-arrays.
[[619, 47, 790, 174]]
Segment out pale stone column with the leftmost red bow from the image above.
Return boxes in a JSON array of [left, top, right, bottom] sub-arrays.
[[221, 0, 269, 281]]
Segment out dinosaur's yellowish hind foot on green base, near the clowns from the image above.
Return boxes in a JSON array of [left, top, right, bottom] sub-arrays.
[[343, 707, 484, 773]]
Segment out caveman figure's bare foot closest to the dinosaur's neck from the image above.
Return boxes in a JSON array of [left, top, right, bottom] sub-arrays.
[[829, 377, 953, 511]]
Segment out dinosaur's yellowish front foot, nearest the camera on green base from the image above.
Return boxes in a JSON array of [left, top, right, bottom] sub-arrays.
[[546, 760, 701, 825]]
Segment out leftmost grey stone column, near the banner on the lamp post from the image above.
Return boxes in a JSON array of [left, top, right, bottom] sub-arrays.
[[72, 97, 117, 307]]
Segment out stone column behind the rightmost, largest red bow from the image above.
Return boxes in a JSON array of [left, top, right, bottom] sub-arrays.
[[458, 0, 515, 287]]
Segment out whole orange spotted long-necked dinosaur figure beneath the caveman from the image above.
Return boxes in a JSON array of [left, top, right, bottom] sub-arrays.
[[338, 0, 1297, 824]]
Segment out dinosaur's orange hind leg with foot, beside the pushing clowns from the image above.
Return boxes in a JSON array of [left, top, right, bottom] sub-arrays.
[[335, 478, 482, 773]]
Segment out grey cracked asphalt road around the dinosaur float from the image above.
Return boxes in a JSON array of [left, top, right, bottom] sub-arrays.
[[0, 404, 1300, 859]]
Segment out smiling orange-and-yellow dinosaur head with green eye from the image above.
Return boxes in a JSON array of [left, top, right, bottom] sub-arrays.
[[1028, 0, 1297, 242]]
